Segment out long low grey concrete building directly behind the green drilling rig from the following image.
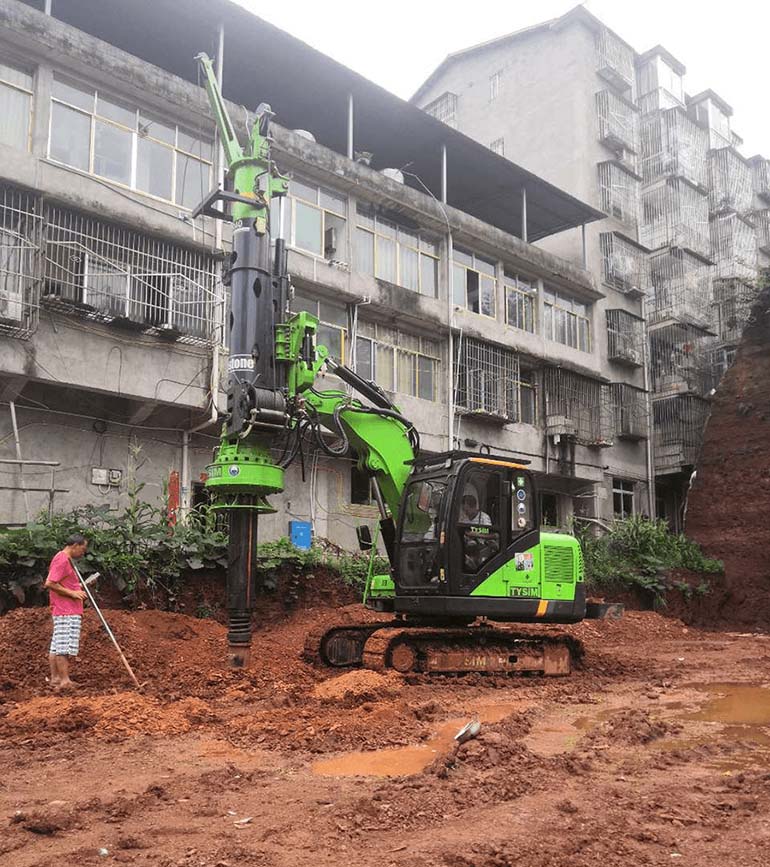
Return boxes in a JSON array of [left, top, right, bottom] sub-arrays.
[[0, 0, 647, 546]]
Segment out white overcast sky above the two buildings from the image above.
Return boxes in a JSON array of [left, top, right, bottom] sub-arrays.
[[237, 0, 770, 157]]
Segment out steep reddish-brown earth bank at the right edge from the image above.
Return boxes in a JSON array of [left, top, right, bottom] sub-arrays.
[[685, 285, 770, 627]]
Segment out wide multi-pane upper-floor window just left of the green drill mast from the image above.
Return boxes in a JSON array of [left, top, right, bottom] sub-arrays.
[[48, 76, 212, 210]]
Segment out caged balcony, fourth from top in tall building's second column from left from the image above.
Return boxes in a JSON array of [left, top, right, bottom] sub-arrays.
[[647, 249, 713, 330]]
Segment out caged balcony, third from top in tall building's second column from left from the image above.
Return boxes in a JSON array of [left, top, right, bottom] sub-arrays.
[[640, 178, 711, 258]]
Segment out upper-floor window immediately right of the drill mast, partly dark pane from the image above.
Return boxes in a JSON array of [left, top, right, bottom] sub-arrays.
[[282, 177, 348, 260]]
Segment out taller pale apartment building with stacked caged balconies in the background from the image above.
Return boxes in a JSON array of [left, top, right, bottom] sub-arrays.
[[412, 7, 770, 526]]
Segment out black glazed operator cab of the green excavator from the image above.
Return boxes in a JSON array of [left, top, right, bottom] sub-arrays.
[[394, 452, 540, 610]]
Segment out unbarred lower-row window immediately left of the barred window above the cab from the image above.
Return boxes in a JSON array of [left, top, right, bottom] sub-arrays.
[[356, 322, 440, 401]]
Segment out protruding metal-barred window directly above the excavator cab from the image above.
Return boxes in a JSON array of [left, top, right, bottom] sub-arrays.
[[456, 338, 536, 424]]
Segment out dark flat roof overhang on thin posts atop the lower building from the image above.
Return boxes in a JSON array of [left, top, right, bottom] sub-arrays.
[[27, 0, 605, 241]]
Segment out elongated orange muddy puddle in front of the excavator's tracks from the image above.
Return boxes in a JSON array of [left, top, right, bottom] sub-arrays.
[[312, 702, 529, 777]]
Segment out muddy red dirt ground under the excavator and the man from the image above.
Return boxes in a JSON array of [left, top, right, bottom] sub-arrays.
[[0, 580, 770, 867]]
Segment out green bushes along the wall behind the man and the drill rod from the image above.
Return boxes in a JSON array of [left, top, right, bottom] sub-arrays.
[[0, 486, 388, 612]]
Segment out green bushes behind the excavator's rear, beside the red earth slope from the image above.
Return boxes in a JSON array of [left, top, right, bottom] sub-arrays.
[[575, 515, 723, 604]]
